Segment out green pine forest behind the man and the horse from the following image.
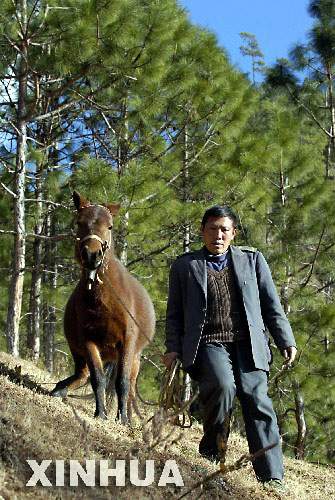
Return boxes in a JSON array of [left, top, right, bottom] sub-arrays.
[[0, 0, 335, 463]]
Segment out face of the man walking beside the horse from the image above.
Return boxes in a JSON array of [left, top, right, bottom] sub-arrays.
[[201, 217, 236, 255]]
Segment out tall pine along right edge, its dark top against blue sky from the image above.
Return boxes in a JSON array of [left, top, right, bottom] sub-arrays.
[[268, 0, 335, 461]]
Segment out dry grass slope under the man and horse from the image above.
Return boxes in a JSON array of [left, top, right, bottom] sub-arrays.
[[0, 353, 335, 500]]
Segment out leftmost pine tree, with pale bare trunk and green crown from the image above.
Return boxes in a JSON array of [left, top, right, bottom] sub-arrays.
[[0, 0, 140, 356]]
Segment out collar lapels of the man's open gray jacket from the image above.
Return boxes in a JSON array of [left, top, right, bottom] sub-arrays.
[[190, 245, 248, 295]]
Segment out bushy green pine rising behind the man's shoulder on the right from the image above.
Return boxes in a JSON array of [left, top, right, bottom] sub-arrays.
[[240, 87, 335, 461]]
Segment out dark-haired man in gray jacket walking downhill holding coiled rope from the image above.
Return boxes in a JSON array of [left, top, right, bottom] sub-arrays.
[[164, 205, 297, 490]]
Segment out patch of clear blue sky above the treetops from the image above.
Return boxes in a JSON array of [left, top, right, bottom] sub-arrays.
[[179, 0, 313, 76]]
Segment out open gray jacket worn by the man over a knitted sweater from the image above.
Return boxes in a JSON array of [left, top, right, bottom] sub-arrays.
[[165, 245, 296, 371]]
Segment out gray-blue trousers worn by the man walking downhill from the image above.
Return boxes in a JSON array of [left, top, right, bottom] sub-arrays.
[[189, 340, 283, 481]]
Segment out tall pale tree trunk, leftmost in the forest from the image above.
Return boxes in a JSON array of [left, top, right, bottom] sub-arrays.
[[6, 0, 28, 356]]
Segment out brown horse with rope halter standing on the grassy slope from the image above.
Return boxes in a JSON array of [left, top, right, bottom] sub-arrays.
[[51, 191, 155, 423]]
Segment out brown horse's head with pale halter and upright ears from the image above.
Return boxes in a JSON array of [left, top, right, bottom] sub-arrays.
[[73, 191, 120, 288]]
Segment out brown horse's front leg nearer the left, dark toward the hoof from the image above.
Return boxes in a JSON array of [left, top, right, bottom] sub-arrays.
[[86, 342, 107, 419]]
